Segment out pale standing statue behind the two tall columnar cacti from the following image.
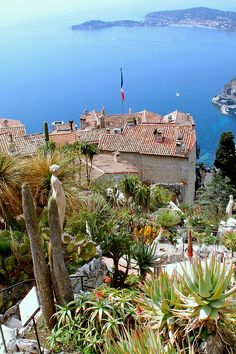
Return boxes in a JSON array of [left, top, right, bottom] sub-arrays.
[[50, 165, 66, 230]]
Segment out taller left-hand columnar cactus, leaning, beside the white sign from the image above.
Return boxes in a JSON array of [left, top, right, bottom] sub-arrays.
[[22, 183, 55, 329]]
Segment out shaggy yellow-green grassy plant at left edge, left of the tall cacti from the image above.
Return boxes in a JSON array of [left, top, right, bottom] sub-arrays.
[[0, 153, 23, 223]]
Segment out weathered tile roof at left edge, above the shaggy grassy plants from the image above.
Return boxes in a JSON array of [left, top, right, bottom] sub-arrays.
[[0, 133, 45, 156]]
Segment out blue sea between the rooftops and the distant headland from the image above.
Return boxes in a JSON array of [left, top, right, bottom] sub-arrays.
[[0, 14, 236, 163]]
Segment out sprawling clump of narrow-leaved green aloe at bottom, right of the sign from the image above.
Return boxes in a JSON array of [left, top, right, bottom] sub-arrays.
[[49, 288, 138, 353]]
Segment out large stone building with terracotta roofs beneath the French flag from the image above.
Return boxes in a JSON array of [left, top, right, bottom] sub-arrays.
[[78, 111, 196, 203]]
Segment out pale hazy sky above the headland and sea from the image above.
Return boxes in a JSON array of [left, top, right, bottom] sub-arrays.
[[0, 0, 236, 27]]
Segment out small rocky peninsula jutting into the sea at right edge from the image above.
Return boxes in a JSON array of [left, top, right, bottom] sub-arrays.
[[212, 78, 236, 115]]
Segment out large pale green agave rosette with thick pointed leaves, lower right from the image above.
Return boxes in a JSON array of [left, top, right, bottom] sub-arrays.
[[173, 253, 236, 321]]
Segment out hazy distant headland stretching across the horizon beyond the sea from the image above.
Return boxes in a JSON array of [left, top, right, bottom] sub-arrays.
[[72, 7, 236, 32]]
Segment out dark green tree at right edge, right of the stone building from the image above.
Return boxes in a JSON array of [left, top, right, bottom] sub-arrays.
[[214, 132, 236, 185]]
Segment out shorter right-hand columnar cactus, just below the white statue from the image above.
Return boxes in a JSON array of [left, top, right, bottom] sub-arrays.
[[48, 197, 74, 305]]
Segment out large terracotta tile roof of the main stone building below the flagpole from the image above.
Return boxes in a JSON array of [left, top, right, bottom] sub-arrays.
[[99, 123, 196, 157]]
